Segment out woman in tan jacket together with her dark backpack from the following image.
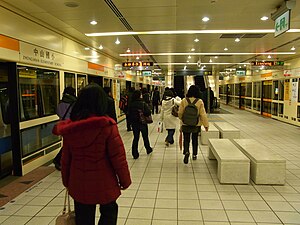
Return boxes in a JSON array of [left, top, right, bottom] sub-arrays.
[[178, 85, 208, 164]]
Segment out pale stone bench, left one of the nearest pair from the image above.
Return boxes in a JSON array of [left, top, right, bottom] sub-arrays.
[[208, 139, 250, 184]]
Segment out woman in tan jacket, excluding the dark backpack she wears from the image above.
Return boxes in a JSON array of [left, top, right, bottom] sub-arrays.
[[178, 85, 209, 164]]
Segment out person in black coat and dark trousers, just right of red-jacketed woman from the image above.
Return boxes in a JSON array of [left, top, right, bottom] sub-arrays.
[[128, 90, 152, 159]]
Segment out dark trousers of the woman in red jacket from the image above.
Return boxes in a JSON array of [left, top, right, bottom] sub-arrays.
[[74, 201, 118, 225]]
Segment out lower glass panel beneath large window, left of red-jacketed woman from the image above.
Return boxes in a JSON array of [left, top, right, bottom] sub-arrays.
[[21, 122, 61, 157]]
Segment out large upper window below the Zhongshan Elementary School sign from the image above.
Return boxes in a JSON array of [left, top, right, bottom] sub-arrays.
[[17, 66, 59, 121]]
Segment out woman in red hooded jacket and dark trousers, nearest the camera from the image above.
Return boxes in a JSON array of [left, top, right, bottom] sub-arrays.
[[54, 84, 131, 225]]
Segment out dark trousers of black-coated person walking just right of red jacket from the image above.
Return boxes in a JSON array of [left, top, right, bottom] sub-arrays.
[[132, 123, 151, 156]]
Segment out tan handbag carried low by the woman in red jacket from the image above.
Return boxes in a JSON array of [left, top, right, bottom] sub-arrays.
[[55, 189, 76, 225]]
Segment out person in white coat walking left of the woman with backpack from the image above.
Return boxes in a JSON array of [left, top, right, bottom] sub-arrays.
[[160, 90, 181, 147]]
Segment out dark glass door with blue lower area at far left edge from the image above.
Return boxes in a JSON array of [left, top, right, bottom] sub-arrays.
[[0, 63, 12, 178]]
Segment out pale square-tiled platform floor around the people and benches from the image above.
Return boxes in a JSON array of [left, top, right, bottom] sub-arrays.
[[0, 107, 300, 225]]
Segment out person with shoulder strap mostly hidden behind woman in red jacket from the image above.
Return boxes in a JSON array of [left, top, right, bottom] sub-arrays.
[[53, 86, 76, 170]]
